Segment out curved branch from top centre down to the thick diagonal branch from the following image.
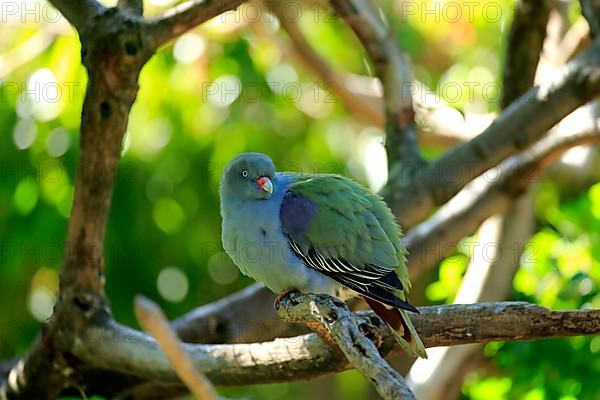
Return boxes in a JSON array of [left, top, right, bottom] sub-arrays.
[[331, 0, 424, 170]]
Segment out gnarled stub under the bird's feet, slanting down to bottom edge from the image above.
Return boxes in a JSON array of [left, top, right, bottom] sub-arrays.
[[278, 292, 415, 400]]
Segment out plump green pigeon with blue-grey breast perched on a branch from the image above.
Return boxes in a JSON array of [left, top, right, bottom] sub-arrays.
[[219, 153, 427, 358]]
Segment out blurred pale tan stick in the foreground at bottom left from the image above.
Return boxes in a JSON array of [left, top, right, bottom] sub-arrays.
[[135, 296, 217, 400]]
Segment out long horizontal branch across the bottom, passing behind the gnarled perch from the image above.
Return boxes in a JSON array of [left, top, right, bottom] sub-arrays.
[[72, 295, 600, 385]]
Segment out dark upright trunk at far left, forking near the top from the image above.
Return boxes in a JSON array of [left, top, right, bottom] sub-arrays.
[[0, 1, 153, 399]]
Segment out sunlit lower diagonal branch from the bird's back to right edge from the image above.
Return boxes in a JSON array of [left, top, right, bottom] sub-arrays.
[[404, 117, 600, 279]]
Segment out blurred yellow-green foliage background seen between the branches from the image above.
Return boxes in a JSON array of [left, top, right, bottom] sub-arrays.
[[0, 0, 600, 400]]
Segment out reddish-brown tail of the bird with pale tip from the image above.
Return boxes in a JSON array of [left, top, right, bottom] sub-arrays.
[[365, 297, 427, 358]]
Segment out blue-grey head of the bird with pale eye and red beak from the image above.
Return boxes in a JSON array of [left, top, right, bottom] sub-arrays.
[[221, 153, 275, 200]]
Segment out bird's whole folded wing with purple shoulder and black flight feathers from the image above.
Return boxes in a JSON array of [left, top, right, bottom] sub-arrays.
[[280, 175, 414, 310]]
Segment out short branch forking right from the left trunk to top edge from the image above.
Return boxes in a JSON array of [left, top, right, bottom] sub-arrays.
[[146, 0, 246, 49]]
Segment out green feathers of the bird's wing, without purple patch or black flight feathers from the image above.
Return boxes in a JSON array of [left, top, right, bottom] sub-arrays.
[[289, 175, 410, 289]]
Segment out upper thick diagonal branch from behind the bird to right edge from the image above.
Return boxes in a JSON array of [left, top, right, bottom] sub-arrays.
[[390, 39, 600, 227]]
